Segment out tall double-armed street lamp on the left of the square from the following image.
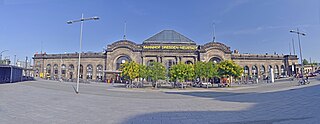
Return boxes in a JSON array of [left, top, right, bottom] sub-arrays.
[[67, 14, 99, 93]]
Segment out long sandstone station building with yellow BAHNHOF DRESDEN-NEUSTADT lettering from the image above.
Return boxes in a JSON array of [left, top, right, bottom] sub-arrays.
[[33, 30, 298, 80]]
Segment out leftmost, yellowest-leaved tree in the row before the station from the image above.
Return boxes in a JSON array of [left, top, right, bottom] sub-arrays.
[[120, 61, 139, 83]]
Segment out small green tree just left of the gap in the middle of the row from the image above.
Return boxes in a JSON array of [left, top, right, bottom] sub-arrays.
[[147, 62, 166, 88]]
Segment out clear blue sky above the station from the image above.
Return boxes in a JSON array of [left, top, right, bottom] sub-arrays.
[[0, 0, 320, 62]]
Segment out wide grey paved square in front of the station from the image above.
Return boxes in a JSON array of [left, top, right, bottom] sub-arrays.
[[0, 78, 320, 124]]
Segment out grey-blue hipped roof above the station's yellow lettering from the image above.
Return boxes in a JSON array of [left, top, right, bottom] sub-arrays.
[[143, 30, 196, 44]]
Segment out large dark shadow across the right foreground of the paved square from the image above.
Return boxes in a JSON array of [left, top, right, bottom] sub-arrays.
[[123, 85, 320, 124]]
